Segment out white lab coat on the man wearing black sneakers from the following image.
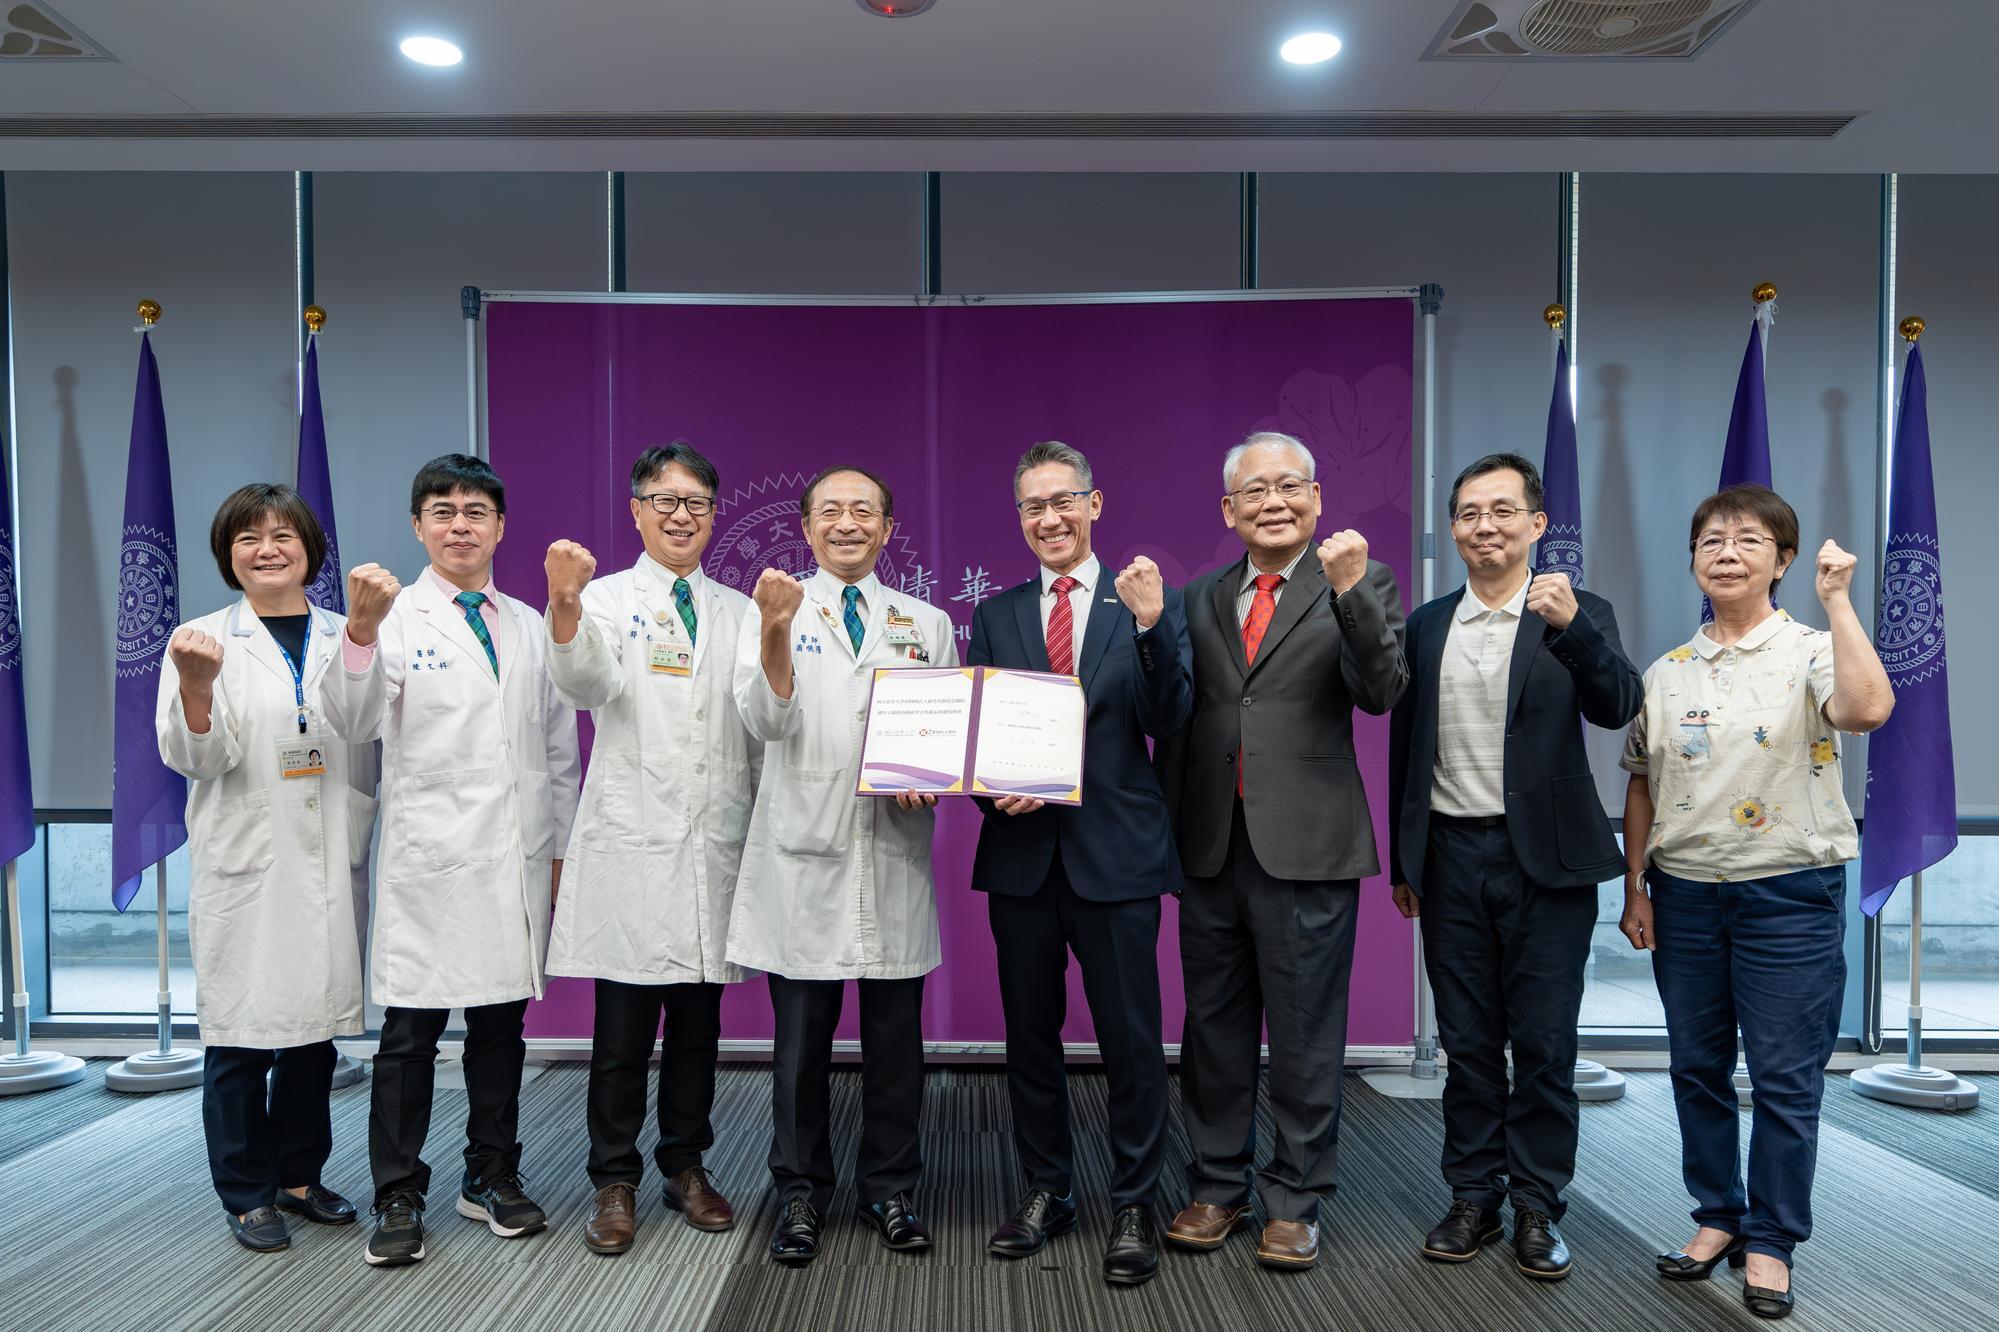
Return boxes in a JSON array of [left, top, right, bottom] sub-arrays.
[[322, 576, 578, 1008]]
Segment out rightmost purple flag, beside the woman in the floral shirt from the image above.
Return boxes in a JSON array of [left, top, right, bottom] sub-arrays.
[[1861, 344, 1957, 916]]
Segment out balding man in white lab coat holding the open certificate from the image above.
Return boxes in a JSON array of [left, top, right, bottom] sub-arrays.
[[728, 466, 958, 1264]]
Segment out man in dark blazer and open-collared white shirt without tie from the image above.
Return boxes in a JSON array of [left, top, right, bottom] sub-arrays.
[[1389, 454, 1643, 1280]]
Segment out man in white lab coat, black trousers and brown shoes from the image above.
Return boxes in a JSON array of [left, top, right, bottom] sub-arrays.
[[546, 442, 764, 1254]]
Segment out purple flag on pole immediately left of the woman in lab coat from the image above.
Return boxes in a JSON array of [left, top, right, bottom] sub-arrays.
[[112, 334, 188, 910]]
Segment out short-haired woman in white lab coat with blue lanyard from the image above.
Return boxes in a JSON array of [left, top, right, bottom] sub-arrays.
[[156, 484, 376, 1252]]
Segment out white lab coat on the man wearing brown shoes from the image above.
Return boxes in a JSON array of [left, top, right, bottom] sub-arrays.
[[548, 554, 764, 986]]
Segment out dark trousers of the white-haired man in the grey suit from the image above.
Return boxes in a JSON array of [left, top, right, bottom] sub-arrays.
[[1179, 800, 1359, 1222]]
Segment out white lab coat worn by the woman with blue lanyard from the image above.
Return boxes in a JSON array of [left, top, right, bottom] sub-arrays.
[[154, 598, 376, 1050]]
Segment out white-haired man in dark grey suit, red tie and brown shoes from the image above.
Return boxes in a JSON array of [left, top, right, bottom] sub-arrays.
[[1159, 432, 1409, 1270]]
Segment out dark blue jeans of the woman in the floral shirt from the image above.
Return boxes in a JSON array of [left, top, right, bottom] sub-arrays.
[[1645, 866, 1847, 1262]]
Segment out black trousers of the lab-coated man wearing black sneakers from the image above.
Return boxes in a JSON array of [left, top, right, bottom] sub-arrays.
[[368, 1000, 528, 1204]]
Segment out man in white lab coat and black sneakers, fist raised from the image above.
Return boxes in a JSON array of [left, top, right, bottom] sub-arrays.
[[320, 454, 578, 1266]]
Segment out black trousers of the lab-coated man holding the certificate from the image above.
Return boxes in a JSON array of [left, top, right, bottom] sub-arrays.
[[770, 976, 924, 1216]]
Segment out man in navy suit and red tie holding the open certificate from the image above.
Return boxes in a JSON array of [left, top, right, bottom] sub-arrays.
[[966, 442, 1189, 1284]]
